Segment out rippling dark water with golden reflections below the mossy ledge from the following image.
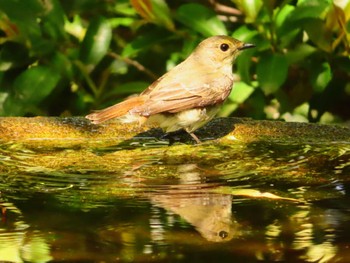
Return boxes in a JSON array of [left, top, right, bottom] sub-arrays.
[[0, 140, 350, 262]]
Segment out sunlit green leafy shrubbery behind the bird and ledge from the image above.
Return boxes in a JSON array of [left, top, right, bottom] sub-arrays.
[[0, 0, 350, 121]]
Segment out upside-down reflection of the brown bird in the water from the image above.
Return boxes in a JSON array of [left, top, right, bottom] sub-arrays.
[[151, 164, 238, 242]]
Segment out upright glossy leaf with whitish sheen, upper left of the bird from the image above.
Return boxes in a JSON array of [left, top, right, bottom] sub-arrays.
[[80, 17, 112, 71]]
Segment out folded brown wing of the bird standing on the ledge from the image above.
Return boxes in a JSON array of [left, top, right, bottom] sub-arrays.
[[132, 73, 232, 116]]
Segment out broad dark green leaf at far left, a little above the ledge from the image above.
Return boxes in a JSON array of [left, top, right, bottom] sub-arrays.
[[14, 66, 60, 106]]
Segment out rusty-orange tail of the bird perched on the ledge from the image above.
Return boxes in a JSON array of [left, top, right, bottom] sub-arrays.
[[85, 96, 145, 124]]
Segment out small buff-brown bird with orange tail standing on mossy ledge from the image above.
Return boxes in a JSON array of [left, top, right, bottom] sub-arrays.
[[86, 36, 255, 143]]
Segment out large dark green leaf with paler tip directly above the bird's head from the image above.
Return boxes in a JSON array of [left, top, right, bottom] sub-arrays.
[[176, 3, 227, 37]]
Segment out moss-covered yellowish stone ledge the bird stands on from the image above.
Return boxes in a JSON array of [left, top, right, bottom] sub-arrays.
[[0, 117, 350, 147]]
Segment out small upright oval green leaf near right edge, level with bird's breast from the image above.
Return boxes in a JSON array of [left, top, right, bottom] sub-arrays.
[[311, 62, 332, 93]]
